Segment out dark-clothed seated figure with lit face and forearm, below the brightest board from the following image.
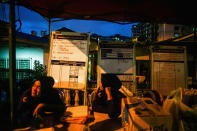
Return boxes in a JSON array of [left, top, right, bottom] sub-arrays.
[[18, 77, 66, 126]]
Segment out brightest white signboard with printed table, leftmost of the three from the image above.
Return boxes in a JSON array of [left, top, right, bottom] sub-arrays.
[[48, 32, 89, 90]]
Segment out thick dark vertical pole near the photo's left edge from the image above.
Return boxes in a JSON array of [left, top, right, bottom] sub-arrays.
[[9, 0, 16, 128]]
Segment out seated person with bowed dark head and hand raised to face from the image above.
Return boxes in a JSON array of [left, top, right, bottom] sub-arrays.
[[89, 74, 123, 118]]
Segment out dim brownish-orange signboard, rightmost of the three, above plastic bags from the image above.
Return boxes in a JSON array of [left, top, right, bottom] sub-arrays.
[[152, 46, 186, 96]]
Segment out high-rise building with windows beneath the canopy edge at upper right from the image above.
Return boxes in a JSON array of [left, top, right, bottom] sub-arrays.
[[132, 23, 193, 41]]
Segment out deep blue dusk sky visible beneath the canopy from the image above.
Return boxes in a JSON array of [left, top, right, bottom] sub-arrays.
[[0, 4, 136, 37]]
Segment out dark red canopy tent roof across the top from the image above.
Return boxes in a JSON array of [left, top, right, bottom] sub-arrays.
[[17, 0, 197, 24]]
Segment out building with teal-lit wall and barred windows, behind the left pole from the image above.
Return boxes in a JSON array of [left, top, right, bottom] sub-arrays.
[[0, 21, 49, 79]]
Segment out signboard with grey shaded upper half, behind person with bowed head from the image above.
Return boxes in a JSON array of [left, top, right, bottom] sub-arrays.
[[97, 42, 135, 90]]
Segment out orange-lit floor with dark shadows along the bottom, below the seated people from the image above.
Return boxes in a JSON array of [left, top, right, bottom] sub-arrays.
[[14, 112, 123, 131]]
